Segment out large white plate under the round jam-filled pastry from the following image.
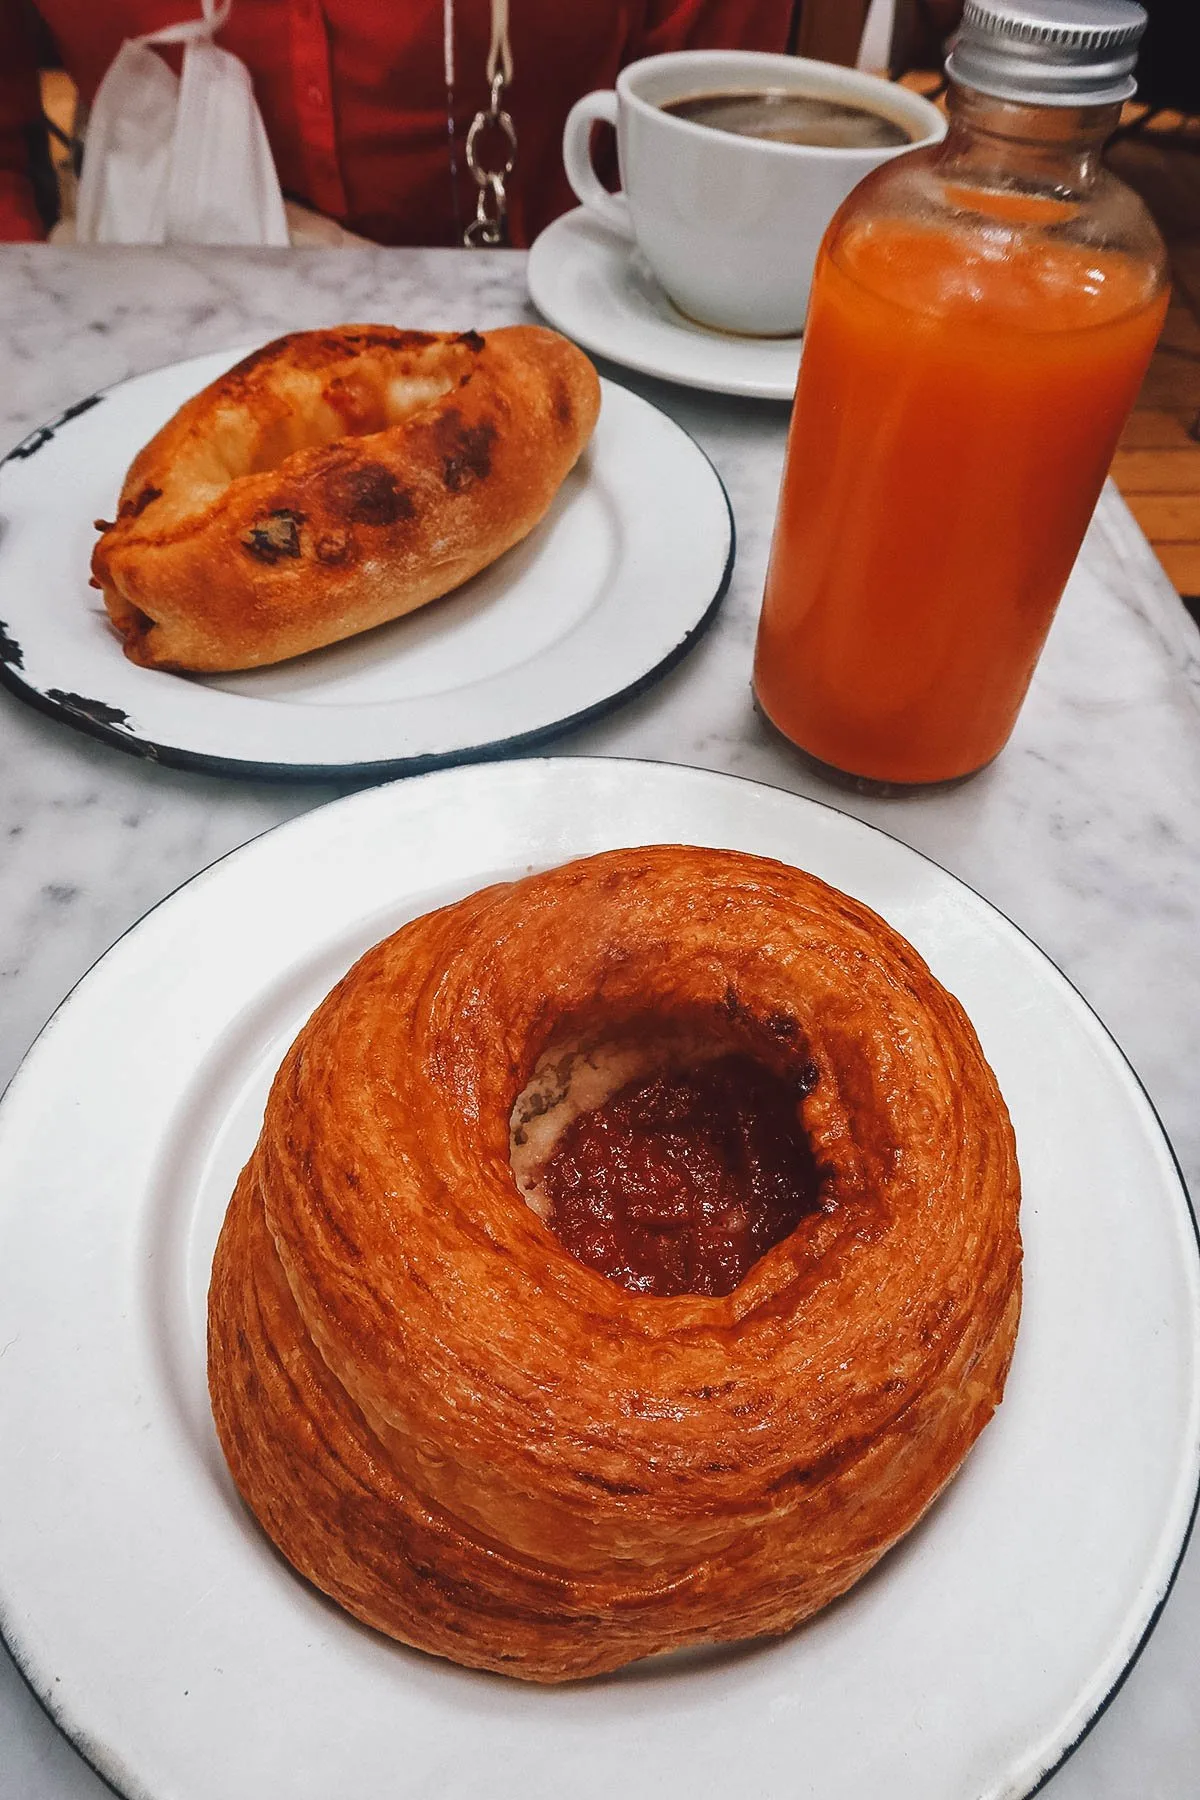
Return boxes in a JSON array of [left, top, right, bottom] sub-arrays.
[[0, 758, 1200, 1800]]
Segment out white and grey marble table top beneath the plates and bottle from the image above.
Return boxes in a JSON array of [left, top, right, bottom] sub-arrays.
[[0, 247, 1200, 1800]]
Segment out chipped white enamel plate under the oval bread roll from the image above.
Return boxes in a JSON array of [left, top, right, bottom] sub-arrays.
[[0, 346, 734, 776]]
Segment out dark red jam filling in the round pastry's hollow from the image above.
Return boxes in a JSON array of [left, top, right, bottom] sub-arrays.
[[542, 1053, 820, 1296]]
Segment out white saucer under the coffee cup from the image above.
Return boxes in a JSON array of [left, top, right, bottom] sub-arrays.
[[529, 207, 801, 401]]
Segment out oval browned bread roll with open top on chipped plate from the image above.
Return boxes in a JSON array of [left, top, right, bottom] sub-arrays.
[[92, 326, 599, 671]]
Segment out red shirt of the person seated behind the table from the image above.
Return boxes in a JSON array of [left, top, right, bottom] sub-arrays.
[[0, 0, 793, 245]]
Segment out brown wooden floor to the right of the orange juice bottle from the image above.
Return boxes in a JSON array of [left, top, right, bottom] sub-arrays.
[[1108, 113, 1200, 623]]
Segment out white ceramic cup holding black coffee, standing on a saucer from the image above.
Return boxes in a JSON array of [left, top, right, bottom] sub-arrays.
[[563, 50, 946, 337]]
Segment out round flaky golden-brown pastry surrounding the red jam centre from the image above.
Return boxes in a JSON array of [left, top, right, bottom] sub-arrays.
[[209, 846, 1020, 1681]]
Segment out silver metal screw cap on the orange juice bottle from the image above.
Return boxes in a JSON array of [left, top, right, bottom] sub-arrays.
[[946, 0, 1146, 106]]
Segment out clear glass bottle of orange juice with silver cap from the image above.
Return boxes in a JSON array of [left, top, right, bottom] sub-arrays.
[[754, 0, 1168, 788]]
